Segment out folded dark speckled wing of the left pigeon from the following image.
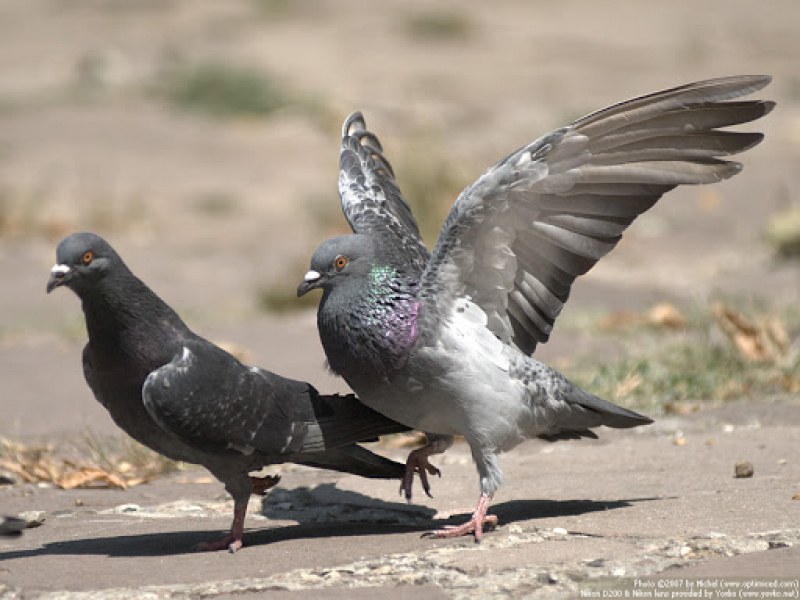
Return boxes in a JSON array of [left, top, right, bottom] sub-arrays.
[[142, 338, 408, 457]]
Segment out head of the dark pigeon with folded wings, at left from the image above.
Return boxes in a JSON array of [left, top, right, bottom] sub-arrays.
[[47, 233, 120, 294]]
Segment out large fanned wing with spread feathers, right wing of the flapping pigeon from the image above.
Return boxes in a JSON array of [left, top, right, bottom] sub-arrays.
[[421, 76, 774, 354]]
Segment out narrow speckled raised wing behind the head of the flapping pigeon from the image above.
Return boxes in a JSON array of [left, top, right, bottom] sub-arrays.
[[339, 112, 429, 272]]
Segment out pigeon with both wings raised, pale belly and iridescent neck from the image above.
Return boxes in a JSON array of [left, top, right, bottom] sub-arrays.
[[298, 76, 773, 540]]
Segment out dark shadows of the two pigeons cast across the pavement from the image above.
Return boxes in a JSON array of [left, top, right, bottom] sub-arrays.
[[0, 484, 661, 561]]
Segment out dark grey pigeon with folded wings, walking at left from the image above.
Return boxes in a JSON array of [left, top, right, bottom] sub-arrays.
[[47, 233, 408, 552]]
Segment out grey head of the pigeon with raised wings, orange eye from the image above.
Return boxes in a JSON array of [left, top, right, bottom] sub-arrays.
[[297, 234, 375, 296]]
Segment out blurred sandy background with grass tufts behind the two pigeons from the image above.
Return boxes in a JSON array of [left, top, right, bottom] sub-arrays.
[[0, 0, 800, 468]]
